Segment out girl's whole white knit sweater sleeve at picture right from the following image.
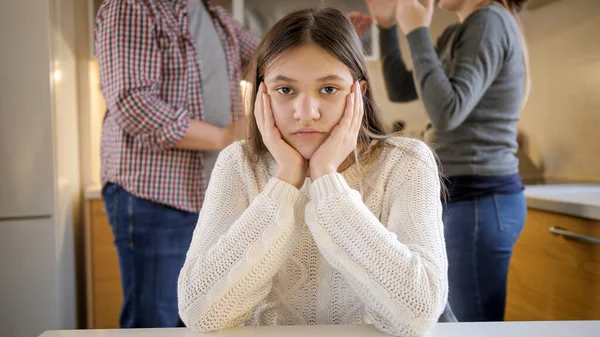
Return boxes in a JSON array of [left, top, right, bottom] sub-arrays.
[[306, 142, 448, 336]]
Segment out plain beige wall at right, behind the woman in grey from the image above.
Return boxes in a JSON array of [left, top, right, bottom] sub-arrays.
[[520, 0, 600, 181]]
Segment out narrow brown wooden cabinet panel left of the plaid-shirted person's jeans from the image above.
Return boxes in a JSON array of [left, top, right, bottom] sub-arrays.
[[88, 200, 123, 329]]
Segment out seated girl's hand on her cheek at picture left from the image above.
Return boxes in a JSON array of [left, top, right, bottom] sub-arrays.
[[254, 83, 308, 189]]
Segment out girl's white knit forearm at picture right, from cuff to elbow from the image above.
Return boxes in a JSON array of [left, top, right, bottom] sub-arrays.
[[306, 174, 446, 336]]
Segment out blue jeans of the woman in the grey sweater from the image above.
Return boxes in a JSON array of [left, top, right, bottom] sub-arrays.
[[443, 192, 527, 322]]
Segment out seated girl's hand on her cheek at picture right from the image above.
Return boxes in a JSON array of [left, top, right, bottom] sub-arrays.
[[309, 81, 364, 181]]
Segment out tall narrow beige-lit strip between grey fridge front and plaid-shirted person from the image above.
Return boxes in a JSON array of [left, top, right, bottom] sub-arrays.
[[49, 0, 83, 328]]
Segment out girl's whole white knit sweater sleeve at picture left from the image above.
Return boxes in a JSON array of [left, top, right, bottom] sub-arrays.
[[177, 143, 307, 331]]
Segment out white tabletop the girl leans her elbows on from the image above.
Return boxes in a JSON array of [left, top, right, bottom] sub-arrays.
[[40, 321, 600, 337]]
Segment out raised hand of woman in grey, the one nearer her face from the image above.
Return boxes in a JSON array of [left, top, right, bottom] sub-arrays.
[[396, 0, 434, 35]]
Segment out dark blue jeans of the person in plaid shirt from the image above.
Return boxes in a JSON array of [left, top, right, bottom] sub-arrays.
[[102, 184, 198, 328]]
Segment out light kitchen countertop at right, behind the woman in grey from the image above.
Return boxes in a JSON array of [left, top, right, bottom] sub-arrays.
[[525, 184, 600, 220]]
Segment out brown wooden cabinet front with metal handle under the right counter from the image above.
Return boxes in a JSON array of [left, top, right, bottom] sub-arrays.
[[506, 209, 600, 321]]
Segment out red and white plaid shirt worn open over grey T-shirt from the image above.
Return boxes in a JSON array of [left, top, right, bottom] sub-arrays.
[[95, 0, 259, 212]]
